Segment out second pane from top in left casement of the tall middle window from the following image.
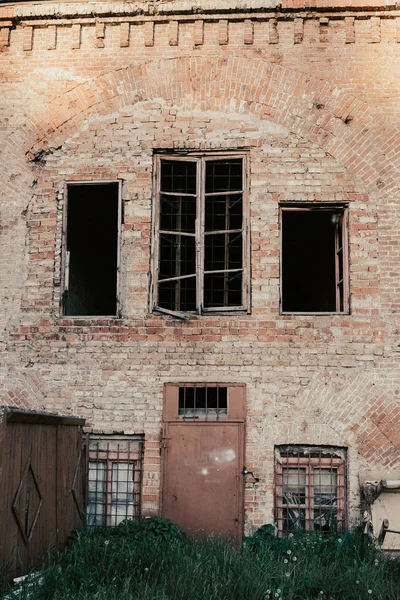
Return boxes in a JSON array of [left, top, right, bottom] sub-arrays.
[[160, 194, 196, 233]]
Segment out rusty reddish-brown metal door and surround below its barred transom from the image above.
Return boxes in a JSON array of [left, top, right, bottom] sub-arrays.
[[162, 385, 245, 543]]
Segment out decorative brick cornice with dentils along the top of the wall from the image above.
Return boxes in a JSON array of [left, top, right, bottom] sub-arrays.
[[0, 11, 400, 52]]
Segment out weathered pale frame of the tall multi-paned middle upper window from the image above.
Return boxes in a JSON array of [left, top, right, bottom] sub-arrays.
[[150, 151, 250, 318]]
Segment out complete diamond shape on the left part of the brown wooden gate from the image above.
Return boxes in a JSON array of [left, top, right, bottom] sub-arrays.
[[11, 458, 43, 544]]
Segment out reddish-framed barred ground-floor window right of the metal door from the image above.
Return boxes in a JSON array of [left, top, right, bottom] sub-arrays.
[[275, 446, 346, 536]]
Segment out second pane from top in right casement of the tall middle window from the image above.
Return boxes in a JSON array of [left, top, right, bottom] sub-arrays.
[[205, 194, 243, 231]]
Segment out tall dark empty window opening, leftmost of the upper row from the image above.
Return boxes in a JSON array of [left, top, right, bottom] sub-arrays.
[[63, 183, 119, 316]]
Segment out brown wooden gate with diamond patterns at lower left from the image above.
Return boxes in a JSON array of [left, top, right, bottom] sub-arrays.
[[0, 408, 86, 577]]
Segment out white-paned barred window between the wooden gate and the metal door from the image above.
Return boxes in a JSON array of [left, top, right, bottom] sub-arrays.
[[87, 436, 143, 527]]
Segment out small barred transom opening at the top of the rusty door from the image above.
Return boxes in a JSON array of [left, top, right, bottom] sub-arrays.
[[178, 385, 228, 420]]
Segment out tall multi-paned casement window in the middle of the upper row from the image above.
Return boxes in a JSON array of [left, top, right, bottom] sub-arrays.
[[153, 153, 248, 313]]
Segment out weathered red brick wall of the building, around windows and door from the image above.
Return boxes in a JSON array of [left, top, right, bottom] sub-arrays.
[[0, 2, 400, 526]]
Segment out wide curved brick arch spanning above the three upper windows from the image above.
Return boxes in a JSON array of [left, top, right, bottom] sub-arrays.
[[2, 57, 400, 198]]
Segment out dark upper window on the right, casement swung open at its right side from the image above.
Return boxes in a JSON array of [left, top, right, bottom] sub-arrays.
[[281, 205, 349, 313]]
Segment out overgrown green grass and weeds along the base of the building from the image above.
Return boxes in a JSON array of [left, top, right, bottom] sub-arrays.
[[2, 518, 400, 600]]
